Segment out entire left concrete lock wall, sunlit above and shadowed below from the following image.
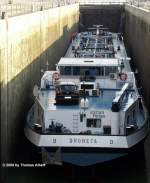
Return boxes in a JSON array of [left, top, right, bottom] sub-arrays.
[[0, 4, 79, 162]]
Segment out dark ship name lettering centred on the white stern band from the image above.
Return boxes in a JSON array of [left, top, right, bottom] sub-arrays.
[[69, 138, 97, 144]]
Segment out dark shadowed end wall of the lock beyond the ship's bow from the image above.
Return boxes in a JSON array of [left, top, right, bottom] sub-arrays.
[[79, 5, 124, 32]]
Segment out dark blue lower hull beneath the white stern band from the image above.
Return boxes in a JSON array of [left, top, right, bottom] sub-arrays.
[[45, 141, 145, 166]]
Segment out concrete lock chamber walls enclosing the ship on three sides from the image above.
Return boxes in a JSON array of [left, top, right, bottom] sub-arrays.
[[0, 1, 150, 166]]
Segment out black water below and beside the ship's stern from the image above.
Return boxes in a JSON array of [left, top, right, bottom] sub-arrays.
[[4, 135, 150, 183]]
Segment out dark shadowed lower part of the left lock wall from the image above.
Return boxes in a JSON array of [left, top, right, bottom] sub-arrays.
[[1, 24, 77, 166]]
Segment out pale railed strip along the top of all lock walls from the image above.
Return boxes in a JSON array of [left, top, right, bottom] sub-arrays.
[[0, 0, 150, 19]]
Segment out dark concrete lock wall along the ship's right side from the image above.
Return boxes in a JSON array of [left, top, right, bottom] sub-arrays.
[[124, 5, 150, 110]]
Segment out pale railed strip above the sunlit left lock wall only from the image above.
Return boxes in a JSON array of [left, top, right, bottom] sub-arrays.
[[0, 0, 78, 19]]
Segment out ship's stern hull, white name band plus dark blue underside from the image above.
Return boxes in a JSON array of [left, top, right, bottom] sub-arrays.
[[25, 121, 149, 166]]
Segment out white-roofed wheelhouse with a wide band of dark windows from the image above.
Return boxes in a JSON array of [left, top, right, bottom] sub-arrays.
[[57, 58, 119, 79]]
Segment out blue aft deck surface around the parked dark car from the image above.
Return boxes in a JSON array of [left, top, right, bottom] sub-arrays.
[[38, 89, 134, 110]]
